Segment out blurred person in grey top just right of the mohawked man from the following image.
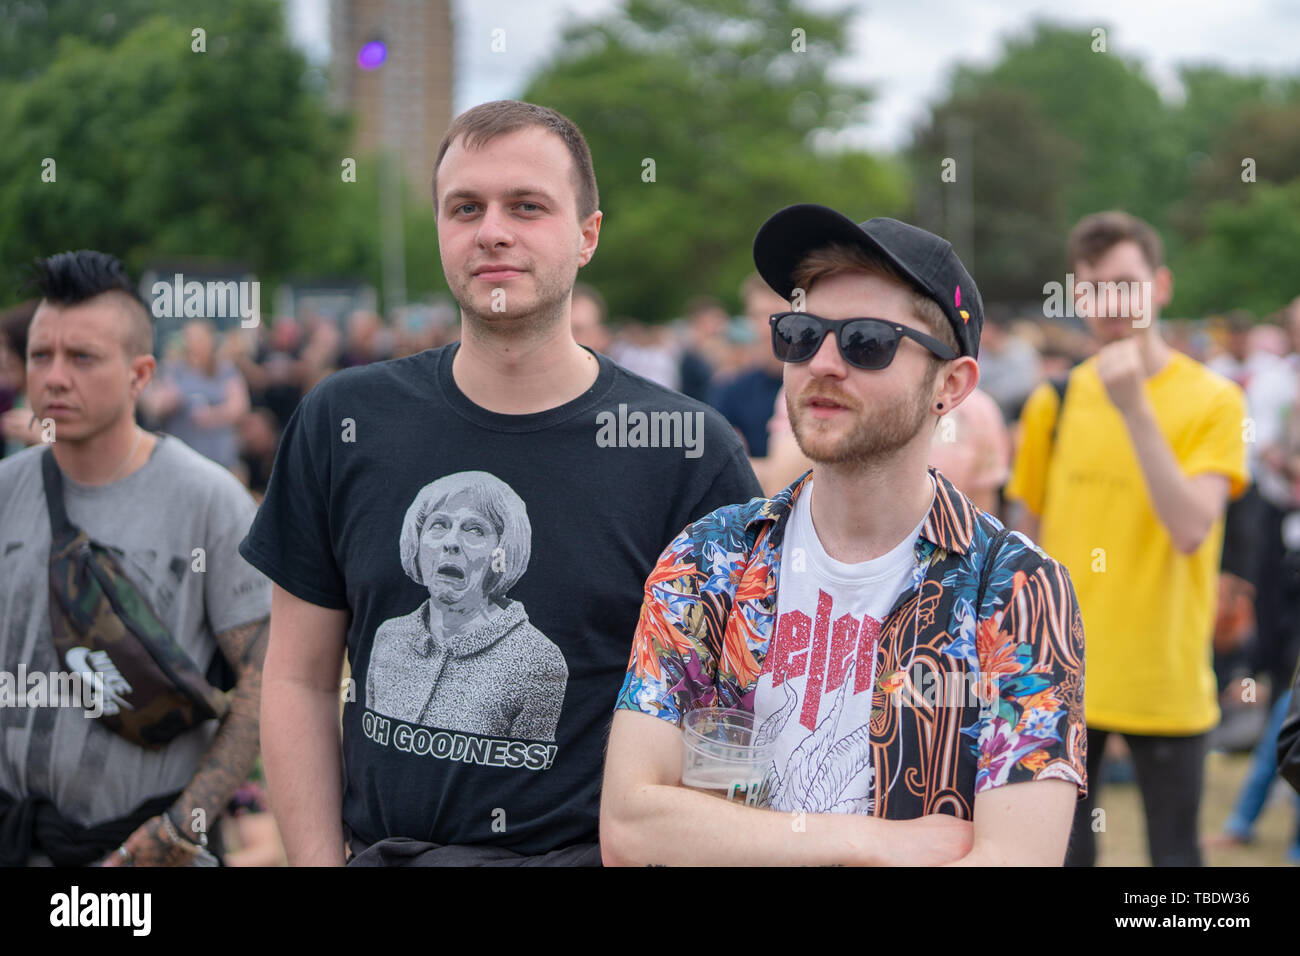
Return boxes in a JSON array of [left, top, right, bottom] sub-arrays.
[[140, 319, 250, 470]]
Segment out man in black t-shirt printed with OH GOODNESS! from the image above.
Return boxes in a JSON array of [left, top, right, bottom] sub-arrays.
[[241, 101, 759, 865]]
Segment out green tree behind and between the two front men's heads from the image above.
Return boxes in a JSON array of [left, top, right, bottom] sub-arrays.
[[523, 0, 906, 321]]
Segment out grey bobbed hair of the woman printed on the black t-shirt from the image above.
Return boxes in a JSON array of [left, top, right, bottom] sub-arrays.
[[399, 471, 533, 600]]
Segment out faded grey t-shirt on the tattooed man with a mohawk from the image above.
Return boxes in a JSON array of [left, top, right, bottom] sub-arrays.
[[0, 436, 270, 826]]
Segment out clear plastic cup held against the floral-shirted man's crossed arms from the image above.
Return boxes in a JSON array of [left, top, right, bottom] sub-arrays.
[[681, 708, 774, 806]]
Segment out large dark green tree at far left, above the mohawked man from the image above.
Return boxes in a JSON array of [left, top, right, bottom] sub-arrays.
[[0, 0, 347, 298]]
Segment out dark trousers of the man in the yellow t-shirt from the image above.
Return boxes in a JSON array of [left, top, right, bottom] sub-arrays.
[[1065, 727, 1209, 866]]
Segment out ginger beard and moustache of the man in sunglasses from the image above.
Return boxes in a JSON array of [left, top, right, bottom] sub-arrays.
[[785, 375, 933, 464]]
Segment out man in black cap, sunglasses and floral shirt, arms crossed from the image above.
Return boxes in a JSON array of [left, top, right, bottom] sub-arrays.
[[601, 206, 1087, 865]]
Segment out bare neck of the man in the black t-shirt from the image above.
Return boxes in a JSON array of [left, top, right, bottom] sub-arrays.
[[451, 321, 601, 415]]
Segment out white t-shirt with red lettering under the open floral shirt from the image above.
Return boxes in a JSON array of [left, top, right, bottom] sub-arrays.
[[754, 480, 926, 813]]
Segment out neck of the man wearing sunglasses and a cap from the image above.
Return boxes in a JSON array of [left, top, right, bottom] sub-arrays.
[[811, 442, 935, 564]]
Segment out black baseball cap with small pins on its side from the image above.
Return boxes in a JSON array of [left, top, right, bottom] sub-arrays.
[[754, 203, 984, 356]]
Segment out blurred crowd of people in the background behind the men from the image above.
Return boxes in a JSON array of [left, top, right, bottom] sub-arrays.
[[0, 264, 1300, 862]]
